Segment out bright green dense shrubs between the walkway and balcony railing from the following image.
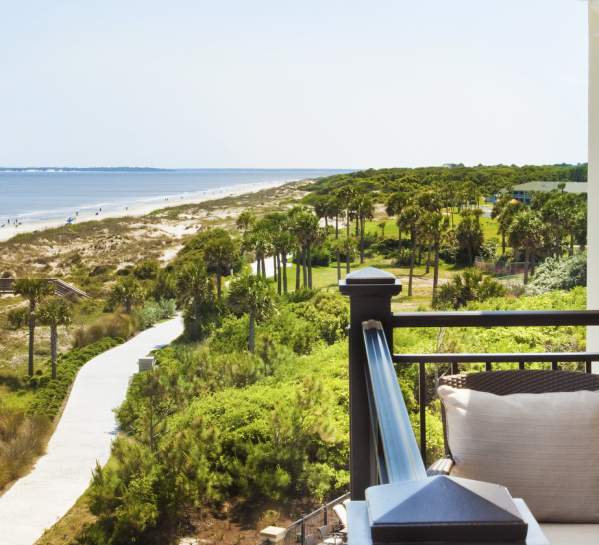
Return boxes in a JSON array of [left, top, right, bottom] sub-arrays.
[[74, 282, 585, 544]]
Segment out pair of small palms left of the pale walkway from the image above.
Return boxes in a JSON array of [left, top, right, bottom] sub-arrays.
[[12, 278, 72, 378]]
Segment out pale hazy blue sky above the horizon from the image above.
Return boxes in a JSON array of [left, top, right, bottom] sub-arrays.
[[0, 0, 588, 168]]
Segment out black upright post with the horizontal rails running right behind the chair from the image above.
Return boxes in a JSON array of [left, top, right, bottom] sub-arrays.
[[339, 267, 599, 500]]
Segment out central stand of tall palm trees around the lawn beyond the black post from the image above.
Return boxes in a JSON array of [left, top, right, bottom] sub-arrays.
[[237, 178, 482, 295]]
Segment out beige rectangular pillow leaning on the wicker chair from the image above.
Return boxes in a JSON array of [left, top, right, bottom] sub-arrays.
[[439, 386, 599, 520]]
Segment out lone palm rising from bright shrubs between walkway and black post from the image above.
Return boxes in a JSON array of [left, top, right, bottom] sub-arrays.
[[229, 274, 275, 353]]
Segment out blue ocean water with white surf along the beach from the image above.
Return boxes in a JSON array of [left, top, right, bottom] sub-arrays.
[[0, 169, 349, 226]]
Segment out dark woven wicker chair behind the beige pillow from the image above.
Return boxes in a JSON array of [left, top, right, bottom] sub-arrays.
[[427, 371, 599, 545]]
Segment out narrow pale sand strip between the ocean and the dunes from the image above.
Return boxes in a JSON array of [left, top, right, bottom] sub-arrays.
[[0, 179, 296, 242]]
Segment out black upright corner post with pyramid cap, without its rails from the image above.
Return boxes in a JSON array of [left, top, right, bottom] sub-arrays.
[[339, 267, 401, 500]]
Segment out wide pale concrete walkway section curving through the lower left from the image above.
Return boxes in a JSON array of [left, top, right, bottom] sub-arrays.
[[0, 317, 183, 545]]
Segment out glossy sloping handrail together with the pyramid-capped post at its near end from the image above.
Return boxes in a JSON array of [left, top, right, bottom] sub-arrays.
[[349, 314, 536, 545]]
